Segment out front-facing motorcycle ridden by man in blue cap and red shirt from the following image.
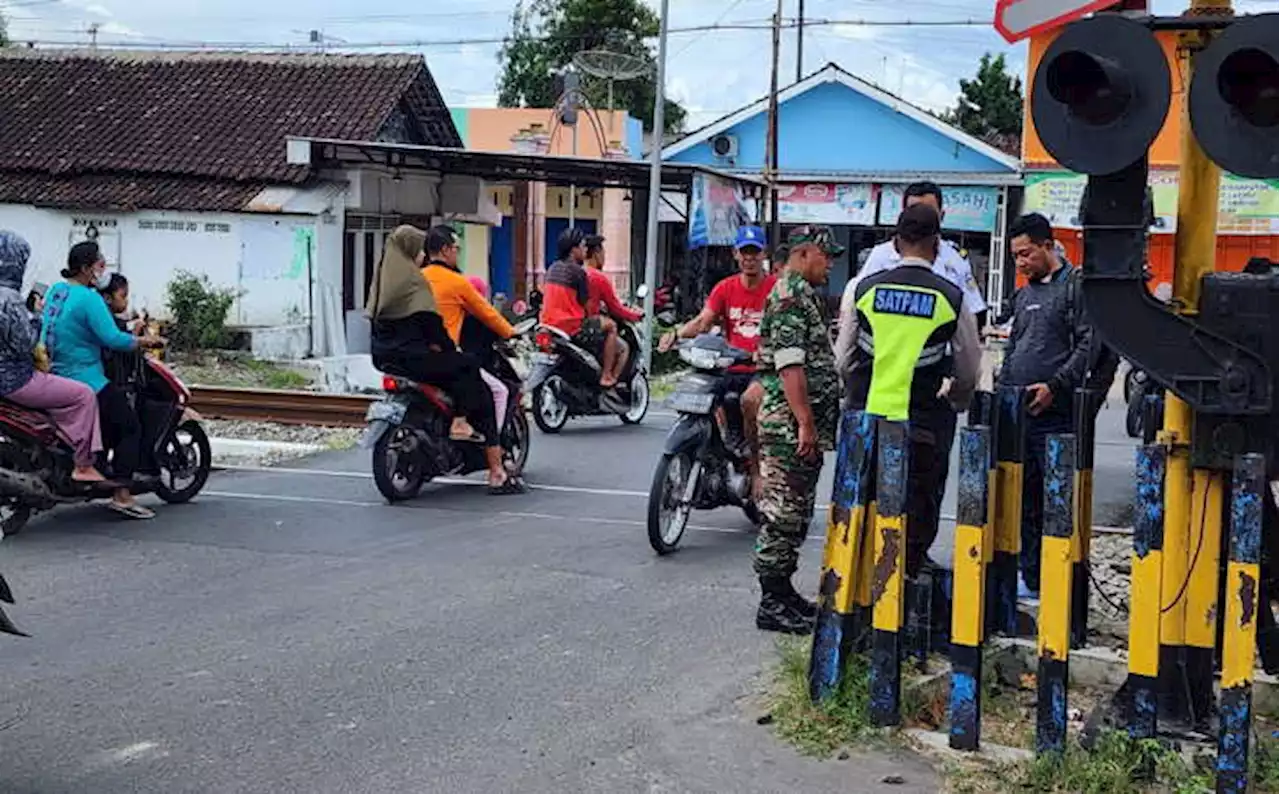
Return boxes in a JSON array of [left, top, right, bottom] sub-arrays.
[[646, 334, 760, 555]]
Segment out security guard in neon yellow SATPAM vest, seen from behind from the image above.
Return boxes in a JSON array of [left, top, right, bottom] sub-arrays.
[[836, 204, 982, 576]]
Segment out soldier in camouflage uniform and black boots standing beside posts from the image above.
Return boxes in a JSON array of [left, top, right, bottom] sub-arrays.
[[755, 225, 845, 634]]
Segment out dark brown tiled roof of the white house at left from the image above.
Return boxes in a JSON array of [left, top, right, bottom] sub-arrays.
[[0, 47, 462, 209]]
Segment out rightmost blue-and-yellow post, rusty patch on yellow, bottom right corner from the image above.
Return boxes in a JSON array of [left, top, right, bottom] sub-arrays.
[[1217, 455, 1267, 793]]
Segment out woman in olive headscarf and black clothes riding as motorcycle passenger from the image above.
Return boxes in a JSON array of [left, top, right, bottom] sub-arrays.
[[365, 225, 524, 494]]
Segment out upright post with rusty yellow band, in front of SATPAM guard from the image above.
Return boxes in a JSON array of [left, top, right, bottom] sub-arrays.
[[870, 419, 910, 727]]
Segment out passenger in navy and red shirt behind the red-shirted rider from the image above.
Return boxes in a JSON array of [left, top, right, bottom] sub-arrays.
[[539, 227, 618, 389]]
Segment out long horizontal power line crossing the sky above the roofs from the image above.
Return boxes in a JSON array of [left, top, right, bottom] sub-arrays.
[[7, 19, 992, 50]]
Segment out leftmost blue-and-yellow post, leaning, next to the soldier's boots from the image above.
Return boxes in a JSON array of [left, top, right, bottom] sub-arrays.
[[809, 411, 876, 703]]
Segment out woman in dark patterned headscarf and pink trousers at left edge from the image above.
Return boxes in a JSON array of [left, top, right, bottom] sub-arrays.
[[0, 231, 106, 483]]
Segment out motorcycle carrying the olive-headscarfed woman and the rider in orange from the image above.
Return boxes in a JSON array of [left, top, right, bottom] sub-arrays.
[[358, 319, 536, 503]]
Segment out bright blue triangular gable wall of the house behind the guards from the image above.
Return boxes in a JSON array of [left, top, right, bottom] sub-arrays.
[[667, 83, 1009, 174]]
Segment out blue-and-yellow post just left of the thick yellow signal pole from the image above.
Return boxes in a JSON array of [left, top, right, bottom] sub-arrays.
[[1128, 444, 1167, 739]]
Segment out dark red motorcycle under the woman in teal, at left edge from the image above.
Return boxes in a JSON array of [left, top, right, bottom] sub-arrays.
[[0, 356, 212, 535]]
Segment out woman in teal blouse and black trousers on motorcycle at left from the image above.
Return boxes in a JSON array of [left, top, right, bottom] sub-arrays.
[[44, 242, 164, 519]]
